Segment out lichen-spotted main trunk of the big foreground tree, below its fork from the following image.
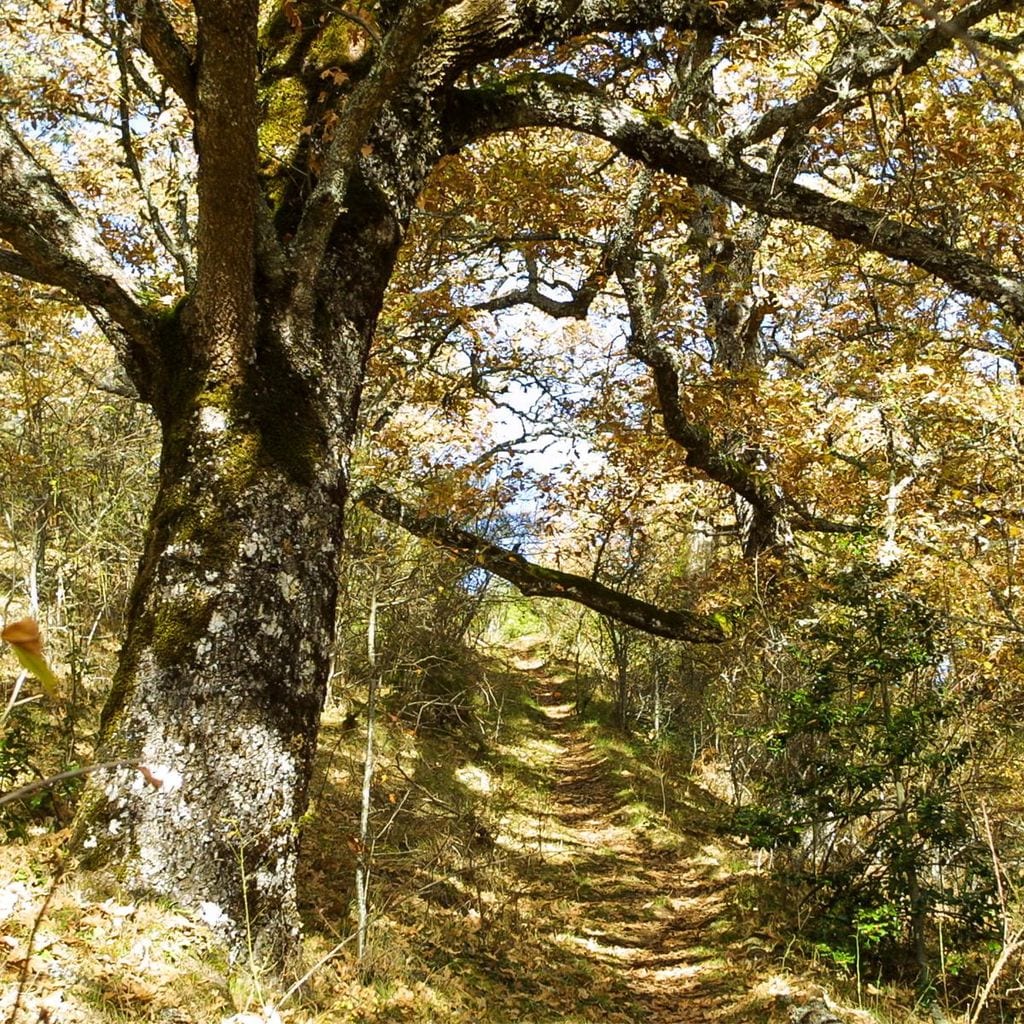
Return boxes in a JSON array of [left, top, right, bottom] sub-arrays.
[[74, 333, 345, 956]]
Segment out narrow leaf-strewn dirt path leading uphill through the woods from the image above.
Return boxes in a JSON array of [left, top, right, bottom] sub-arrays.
[[495, 647, 765, 1024]]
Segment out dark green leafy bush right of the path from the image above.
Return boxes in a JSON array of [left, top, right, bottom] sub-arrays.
[[733, 564, 996, 983]]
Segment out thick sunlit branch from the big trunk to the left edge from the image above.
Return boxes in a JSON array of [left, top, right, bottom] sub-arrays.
[[0, 121, 156, 360]]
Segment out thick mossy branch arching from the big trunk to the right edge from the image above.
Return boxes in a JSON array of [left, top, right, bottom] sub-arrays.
[[450, 75, 1024, 324]]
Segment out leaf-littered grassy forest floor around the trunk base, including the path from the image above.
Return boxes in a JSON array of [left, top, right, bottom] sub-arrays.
[[0, 641, 921, 1024]]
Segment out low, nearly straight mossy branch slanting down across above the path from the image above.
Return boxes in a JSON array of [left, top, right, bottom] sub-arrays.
[[357, 487, 729, 643]]
